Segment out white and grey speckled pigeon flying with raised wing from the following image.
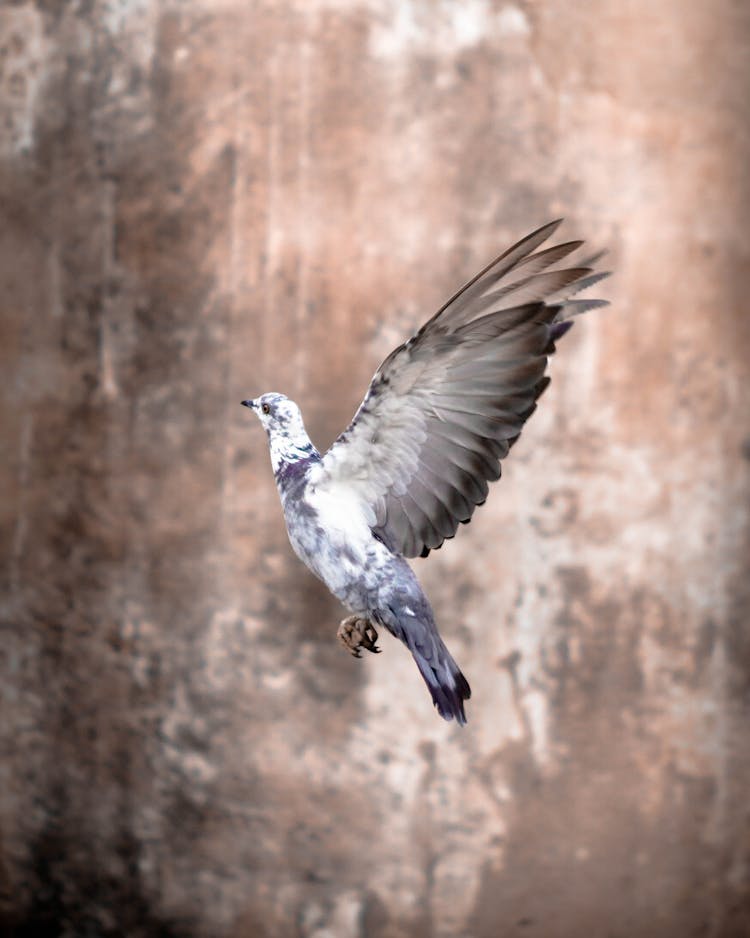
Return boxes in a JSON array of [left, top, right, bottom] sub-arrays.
[[242, 219, 608, 725]]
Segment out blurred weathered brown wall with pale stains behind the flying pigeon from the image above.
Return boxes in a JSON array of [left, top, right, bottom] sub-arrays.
[[0, 0, 750, 938]]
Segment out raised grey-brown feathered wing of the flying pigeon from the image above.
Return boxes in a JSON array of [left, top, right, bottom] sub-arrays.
[[316, 221, 607, 557]]
